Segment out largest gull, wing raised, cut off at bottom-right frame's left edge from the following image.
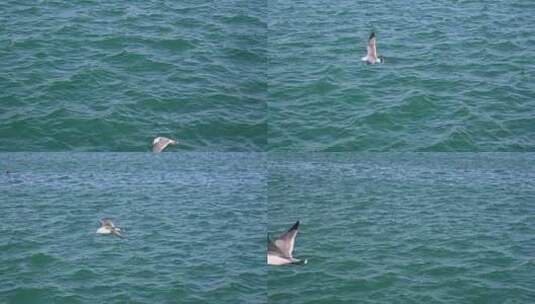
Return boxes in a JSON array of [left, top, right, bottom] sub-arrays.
[[267, 221, 308, 266]]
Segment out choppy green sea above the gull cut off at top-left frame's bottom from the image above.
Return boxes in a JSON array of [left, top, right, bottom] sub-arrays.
[[0, 0, 267, 152]]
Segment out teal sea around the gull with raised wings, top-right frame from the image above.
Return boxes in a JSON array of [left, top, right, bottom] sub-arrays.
[[268, 0, 535, 151]]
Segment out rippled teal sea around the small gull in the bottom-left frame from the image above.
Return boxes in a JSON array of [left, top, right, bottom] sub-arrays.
[[0, 153, 267, 304]]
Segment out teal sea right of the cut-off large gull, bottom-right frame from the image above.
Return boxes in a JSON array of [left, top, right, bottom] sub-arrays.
[[268, 153, 535, 304]]
